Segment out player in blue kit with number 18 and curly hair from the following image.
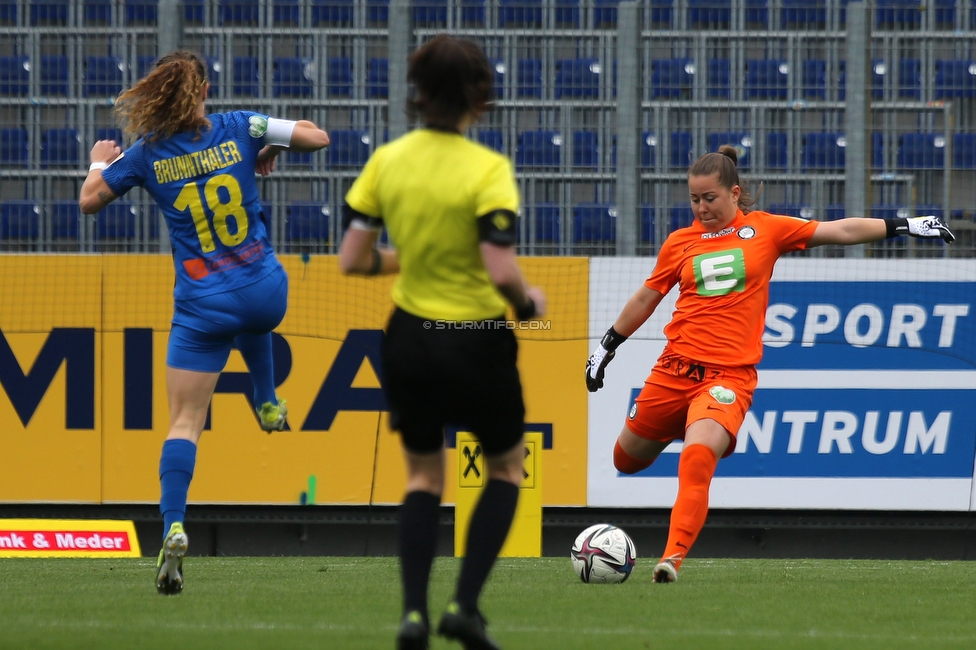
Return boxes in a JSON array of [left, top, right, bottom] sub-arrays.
[[79, 51, 329, 594]]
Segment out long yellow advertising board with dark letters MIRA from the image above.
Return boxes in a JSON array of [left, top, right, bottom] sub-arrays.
[[0, 255, 588, 505]]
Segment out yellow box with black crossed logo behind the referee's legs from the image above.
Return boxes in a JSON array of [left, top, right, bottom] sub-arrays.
[[454, 432, 542, 557]]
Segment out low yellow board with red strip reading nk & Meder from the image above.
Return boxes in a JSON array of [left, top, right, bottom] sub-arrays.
[[0, 519, 142, 557]]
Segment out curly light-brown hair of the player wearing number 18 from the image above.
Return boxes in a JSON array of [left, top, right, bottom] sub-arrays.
[[115, 50, 210, 143]]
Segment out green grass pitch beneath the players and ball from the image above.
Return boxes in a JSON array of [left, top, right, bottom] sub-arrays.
[[0, 556, 976, 650]]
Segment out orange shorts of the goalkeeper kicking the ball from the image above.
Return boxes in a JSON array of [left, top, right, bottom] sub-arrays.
[[626, 350, 757, 458]]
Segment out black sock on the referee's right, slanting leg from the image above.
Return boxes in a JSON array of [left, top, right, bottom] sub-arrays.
[[455, 479, 519, 614]]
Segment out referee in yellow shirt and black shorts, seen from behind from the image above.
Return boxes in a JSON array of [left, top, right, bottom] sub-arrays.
[[339, 34, 546, 649]]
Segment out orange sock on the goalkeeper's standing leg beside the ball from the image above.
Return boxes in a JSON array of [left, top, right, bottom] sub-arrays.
[[661, 445, 718, 568]]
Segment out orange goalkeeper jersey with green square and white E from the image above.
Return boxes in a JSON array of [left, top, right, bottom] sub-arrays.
[[644, 211, 817, 366]]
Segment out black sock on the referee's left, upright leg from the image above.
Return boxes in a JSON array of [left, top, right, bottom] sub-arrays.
[[397, 491, 441, 621]]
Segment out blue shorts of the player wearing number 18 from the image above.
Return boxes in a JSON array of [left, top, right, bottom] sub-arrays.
[[166, 269, 288, 372]]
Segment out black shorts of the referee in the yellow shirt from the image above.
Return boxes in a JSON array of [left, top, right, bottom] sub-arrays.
[[383, 308, 525, 456]]
